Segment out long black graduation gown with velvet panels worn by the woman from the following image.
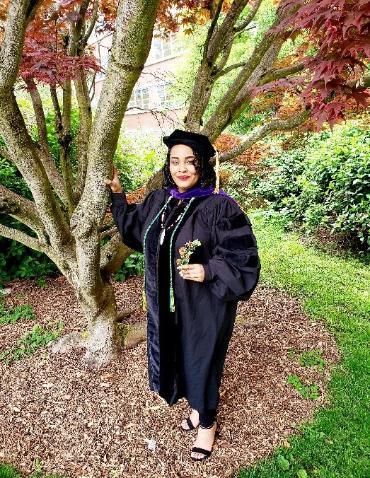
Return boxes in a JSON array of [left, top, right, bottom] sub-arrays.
[[111, 189, 261, 413]]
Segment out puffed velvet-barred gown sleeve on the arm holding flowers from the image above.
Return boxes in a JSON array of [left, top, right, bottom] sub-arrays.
[[203, 199, 261, 301]]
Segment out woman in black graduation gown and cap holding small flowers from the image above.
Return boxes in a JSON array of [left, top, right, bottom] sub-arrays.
[[106, 130, 261, 461]]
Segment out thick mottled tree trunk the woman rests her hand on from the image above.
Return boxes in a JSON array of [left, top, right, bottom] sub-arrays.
[[62, 0, 158, 367]]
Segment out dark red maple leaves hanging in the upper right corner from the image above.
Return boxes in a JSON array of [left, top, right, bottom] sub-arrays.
[[272, 0, 370, 129]]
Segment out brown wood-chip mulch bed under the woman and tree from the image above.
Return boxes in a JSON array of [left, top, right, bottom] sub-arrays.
[[0, 277, 340, 478]]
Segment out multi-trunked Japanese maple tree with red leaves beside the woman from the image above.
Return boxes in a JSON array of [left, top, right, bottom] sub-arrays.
[[0, 0, 370, 367]]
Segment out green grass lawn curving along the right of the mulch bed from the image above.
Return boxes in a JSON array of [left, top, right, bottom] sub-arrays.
[[237, 211, 370, 478]]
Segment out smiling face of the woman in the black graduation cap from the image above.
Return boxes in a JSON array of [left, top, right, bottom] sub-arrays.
[[170, 144, 199, 193]]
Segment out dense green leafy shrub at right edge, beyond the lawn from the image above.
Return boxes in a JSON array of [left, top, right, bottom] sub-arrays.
[[251, 121, 370, 252]]
